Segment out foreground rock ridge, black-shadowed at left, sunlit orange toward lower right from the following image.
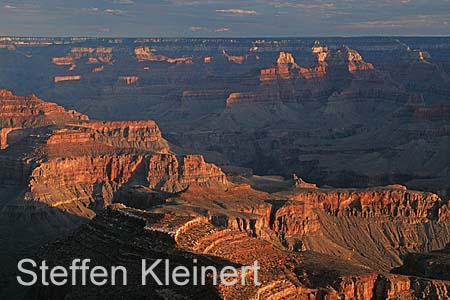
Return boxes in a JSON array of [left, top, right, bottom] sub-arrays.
[[33, 200, 449, 300]]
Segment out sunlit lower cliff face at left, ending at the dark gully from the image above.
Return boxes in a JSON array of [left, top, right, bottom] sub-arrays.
[[25, 155, 142, 206]]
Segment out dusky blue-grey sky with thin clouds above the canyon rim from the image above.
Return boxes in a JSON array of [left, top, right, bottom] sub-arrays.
[[0, 0, 450, 37]]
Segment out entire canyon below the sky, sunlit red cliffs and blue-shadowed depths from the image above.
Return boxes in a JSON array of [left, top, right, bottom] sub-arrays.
[[0, 38, 450, 300]]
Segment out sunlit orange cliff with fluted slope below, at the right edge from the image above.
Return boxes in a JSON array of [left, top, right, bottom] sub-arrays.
[[268, 188, 450, 270]]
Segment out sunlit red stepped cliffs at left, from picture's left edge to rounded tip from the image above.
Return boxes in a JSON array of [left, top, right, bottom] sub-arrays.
[[0, 91, 227, 216]]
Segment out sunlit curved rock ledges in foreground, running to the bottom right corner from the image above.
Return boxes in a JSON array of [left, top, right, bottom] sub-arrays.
[[175, 213, 450, 300]]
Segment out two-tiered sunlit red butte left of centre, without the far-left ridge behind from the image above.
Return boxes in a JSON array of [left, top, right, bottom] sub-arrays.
[[21, 130, 228, 211]]
